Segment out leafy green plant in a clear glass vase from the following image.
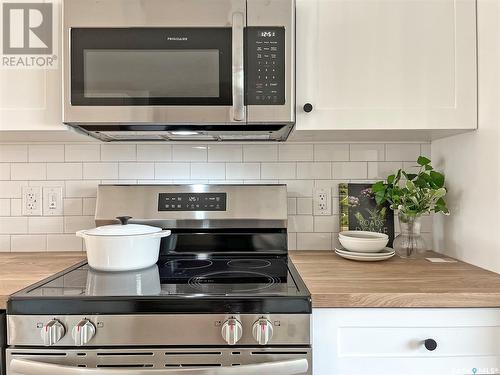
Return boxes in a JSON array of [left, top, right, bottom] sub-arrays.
[[372, 156, 449, 258]]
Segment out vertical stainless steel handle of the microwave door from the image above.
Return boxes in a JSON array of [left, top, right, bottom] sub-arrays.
[[232, 12, 245, 121]]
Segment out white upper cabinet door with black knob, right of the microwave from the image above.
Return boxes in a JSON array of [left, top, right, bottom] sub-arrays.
[[297, 0, 477, 130]]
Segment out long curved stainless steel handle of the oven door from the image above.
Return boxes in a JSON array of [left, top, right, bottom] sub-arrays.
[[9, 358, 309, 375]]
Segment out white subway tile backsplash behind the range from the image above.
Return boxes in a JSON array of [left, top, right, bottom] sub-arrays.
[[0, 143, 432, 251]]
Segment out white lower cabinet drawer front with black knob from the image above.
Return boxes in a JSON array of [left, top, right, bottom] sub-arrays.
[[313, 308, 500, 375]]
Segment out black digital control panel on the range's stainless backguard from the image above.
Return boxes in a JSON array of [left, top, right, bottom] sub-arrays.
[[158, 193, 227, 211]]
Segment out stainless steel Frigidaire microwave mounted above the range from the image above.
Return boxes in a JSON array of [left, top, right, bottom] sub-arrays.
[[63, 0, 295, 141]]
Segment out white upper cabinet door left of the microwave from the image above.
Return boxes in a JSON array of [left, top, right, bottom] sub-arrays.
[[0, 0, 66, 131]]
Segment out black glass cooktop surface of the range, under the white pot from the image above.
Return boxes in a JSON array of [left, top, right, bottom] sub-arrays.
[[24, 257, 299, 298]]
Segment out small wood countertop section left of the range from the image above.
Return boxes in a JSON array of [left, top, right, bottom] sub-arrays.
[[0, 252, 85, 310]]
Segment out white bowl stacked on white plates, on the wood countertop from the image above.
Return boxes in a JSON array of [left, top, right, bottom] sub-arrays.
[[335, 230, 394, 262]]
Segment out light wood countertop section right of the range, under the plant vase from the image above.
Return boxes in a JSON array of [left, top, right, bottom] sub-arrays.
[[290, 251, 500, 307]]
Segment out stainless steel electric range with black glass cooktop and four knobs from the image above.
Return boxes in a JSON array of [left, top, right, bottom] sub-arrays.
[[6, 185, 312, 375]]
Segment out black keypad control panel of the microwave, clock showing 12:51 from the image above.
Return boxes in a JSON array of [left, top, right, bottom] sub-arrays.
[[245, 26, 285, 105]]
